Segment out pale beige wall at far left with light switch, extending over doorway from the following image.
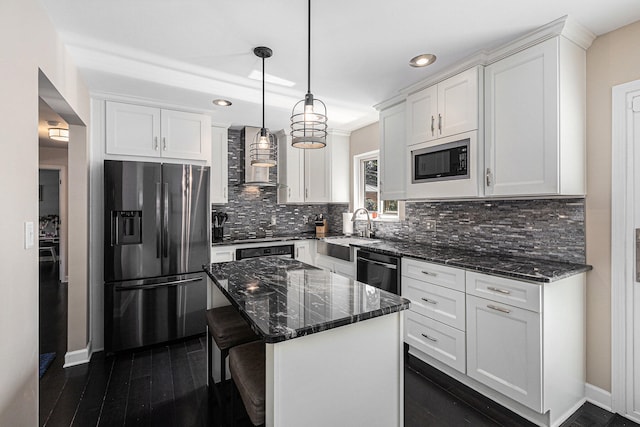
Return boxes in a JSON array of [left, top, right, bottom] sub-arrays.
[[0, 0, 89, 426]]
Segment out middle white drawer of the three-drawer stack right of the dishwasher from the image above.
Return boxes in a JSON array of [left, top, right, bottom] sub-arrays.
[[402, 277, 466, 331]]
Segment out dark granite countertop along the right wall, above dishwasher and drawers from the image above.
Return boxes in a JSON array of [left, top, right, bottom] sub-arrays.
[[352, 240, 593, 283]]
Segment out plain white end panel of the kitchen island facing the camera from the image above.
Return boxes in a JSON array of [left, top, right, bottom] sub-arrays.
[[266, 312, 404, 427]]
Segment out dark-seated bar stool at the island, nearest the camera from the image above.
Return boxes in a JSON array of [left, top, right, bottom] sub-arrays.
[[229, 341, 266, 426]]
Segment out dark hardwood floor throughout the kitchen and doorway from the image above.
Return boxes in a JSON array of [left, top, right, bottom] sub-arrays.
[[40, 263, 638, 427]]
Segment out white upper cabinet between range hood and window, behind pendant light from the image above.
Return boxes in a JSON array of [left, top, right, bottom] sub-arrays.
[[278, 132, 350, 203]]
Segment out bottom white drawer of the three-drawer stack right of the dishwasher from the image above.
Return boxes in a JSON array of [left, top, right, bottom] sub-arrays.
[[404, 310, 466, 374]]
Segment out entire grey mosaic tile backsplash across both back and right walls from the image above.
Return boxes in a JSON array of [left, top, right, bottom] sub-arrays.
[[212, 130, 586, 263]]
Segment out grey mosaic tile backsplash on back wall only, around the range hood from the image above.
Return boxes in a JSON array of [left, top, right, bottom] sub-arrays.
[[211, 129, 349, 239]]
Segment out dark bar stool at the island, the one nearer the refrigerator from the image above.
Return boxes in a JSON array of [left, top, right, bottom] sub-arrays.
[[206, 305, 258, 392]]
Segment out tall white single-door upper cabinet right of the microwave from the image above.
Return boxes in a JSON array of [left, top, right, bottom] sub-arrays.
[[485, 36, 586, 196]]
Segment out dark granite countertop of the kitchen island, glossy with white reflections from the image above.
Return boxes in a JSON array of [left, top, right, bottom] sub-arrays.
[[204, 257, 409, 343]]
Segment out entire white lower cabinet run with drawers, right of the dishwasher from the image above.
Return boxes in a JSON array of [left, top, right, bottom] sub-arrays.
[[401, 257, 585, 426]]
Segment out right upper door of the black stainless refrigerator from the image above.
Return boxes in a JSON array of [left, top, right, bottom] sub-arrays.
[[161, 163, 211, 275]]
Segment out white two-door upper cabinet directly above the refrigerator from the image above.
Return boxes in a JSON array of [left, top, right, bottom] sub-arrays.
[[106, 101, 211, 161]]
